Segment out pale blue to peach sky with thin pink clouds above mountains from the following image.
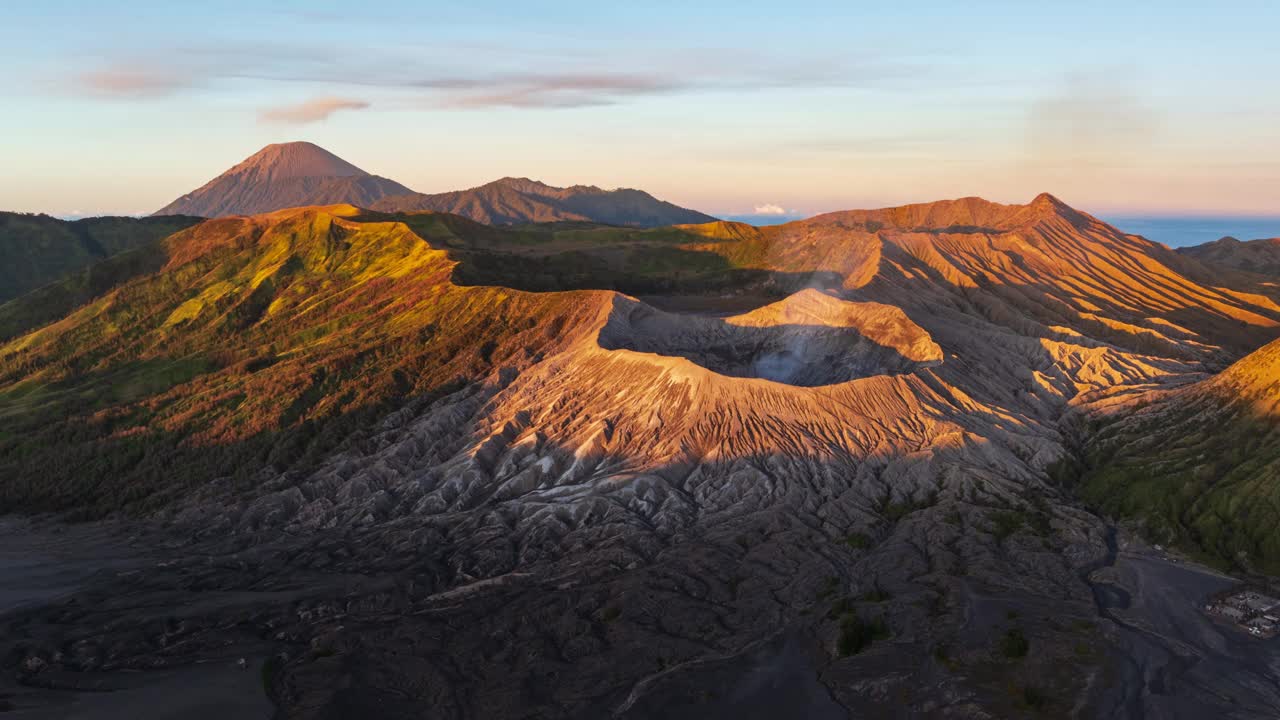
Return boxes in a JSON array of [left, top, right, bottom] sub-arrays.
[[0, 0, 1280, 215]]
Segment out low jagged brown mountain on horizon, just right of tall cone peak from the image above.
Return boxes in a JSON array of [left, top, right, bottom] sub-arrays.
[[374, 178, 716, 227]]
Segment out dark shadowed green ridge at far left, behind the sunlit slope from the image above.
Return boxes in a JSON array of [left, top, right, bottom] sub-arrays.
[[0, 213, 198, 302]]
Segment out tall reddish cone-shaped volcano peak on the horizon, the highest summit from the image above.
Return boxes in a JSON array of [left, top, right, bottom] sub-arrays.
[[155, 142, 412, 218]]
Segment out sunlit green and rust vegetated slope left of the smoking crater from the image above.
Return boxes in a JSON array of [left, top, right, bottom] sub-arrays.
[[0, 209, 604, 515]]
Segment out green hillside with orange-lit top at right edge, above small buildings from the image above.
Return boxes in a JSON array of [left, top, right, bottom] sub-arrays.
[[1080, 343, 1280, 574]]
